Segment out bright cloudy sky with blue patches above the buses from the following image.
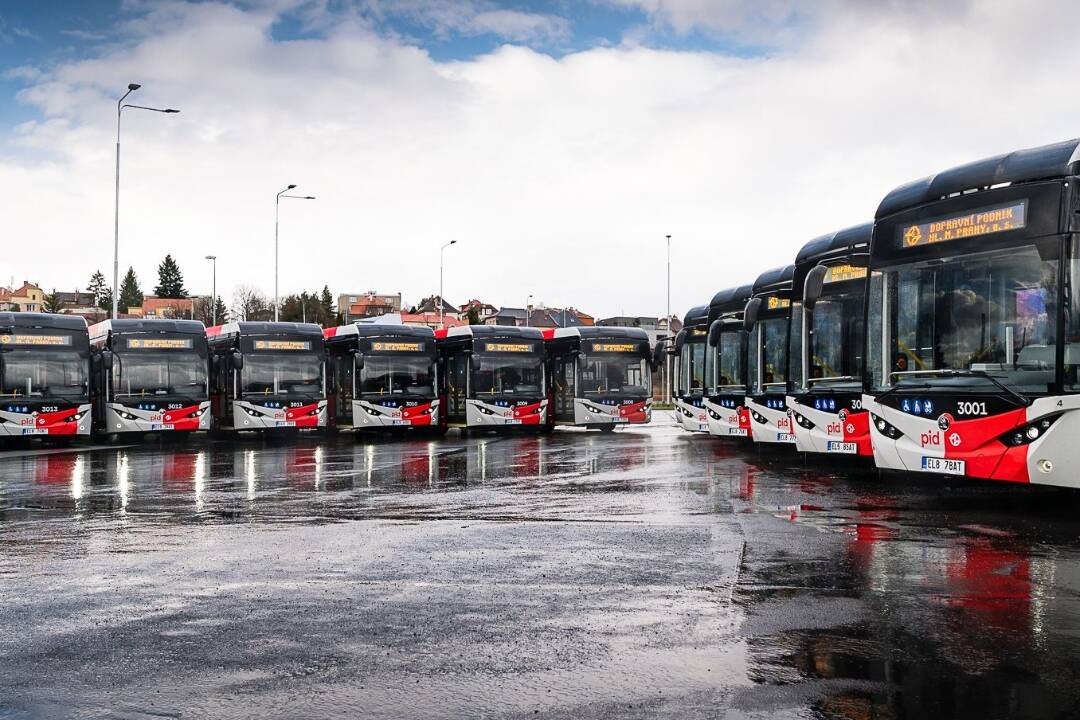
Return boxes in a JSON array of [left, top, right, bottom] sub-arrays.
[[0, 0, 1080, 316]]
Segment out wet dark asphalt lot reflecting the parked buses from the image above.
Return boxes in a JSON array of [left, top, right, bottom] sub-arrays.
[[0, 413, 1080, 720]]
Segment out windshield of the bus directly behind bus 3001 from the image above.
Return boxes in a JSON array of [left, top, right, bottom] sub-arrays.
[[808, 282, 864, 389]]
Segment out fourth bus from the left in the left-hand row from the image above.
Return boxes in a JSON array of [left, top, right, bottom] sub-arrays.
[[323, 324, 445, 430]]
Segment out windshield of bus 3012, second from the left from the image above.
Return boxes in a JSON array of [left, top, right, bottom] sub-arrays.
[[112, 352, 206, 399]]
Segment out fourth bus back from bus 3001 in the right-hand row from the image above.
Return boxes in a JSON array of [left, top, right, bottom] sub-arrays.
[[703, 285, 754, 438]]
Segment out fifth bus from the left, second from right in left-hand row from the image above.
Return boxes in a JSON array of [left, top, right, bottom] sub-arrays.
[[435, 325, 548, 430]]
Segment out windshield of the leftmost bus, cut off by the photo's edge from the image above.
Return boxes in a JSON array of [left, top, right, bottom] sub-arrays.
[[0, 350, 90, 400]]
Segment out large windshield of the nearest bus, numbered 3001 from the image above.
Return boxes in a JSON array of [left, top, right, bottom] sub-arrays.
[[869, 245, 1058, 393]]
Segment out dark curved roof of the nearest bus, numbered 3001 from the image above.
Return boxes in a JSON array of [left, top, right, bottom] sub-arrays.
[[874, 138, 1080, 220]]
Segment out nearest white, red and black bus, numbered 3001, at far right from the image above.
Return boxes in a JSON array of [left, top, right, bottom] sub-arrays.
[[863, 139, 1080, 487]]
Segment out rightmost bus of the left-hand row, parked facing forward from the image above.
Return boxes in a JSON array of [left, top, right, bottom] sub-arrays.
[[544, 327, 652, 431]]
